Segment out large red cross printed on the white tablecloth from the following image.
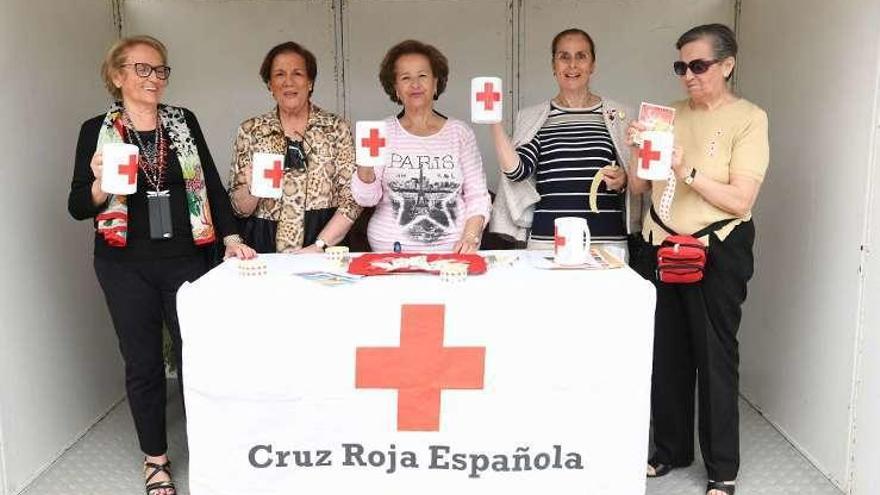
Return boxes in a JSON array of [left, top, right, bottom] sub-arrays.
[[355, 304, 486, 431]]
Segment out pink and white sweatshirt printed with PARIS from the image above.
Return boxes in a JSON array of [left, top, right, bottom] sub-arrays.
[[351, 117, 492, 252]]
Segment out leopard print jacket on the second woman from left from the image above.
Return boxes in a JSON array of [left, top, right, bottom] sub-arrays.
[[229, 104, 362, 253]]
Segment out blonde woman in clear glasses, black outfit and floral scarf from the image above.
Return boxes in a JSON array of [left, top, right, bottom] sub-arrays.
[[68, 36, 254, 495]]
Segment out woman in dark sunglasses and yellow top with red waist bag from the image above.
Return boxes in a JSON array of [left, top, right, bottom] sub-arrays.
[[629, 24, 769, 495]]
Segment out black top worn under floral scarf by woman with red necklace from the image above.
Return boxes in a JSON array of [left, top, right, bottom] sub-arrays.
[[67, 109, 238, 261]]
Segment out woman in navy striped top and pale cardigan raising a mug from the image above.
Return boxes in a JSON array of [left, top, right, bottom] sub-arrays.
[[489, 29, 641, 257]]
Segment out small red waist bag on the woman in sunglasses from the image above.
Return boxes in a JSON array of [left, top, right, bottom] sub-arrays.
[[651, 206, 736, 284]]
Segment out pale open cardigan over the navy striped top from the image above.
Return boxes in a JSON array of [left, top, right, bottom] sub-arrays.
[[489, 98, 642, 241]]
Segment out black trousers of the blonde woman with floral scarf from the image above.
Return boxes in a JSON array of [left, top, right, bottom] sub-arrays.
[[94, 256, 207, 456]]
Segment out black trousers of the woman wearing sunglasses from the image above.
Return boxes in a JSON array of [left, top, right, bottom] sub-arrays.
[[634, 222, 755, 481]]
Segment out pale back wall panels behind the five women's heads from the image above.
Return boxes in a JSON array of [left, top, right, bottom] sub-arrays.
[[123, 0, 735, 189]]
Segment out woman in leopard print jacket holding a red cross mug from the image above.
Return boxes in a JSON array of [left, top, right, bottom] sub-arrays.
[[229, 41, 361, 253]]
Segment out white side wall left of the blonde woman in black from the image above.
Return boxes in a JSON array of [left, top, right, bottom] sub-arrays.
[[0, 0, 123, 494]]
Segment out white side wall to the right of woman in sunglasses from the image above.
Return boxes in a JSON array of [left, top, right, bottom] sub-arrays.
[[738, 0, 880, 489]]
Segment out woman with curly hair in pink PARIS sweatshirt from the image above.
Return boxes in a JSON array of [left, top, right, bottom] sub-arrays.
[[351, 40, 491, 253]]
